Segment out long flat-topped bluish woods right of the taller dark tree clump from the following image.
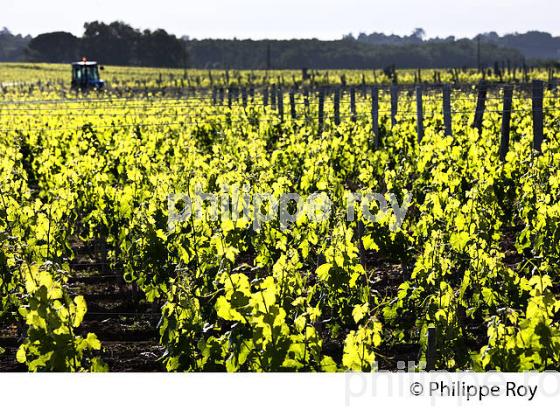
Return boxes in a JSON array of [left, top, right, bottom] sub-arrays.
[[186, 39, 523, 69]]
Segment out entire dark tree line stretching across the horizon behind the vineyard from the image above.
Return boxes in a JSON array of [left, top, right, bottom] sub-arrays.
[[0, 21, 560, 69]]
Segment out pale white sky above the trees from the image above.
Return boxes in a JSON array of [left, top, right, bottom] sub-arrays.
[[0, 0, 560, 39]]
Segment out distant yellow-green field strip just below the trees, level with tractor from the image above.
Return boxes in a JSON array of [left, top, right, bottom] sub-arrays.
[[0, 63, 548, 87]]
